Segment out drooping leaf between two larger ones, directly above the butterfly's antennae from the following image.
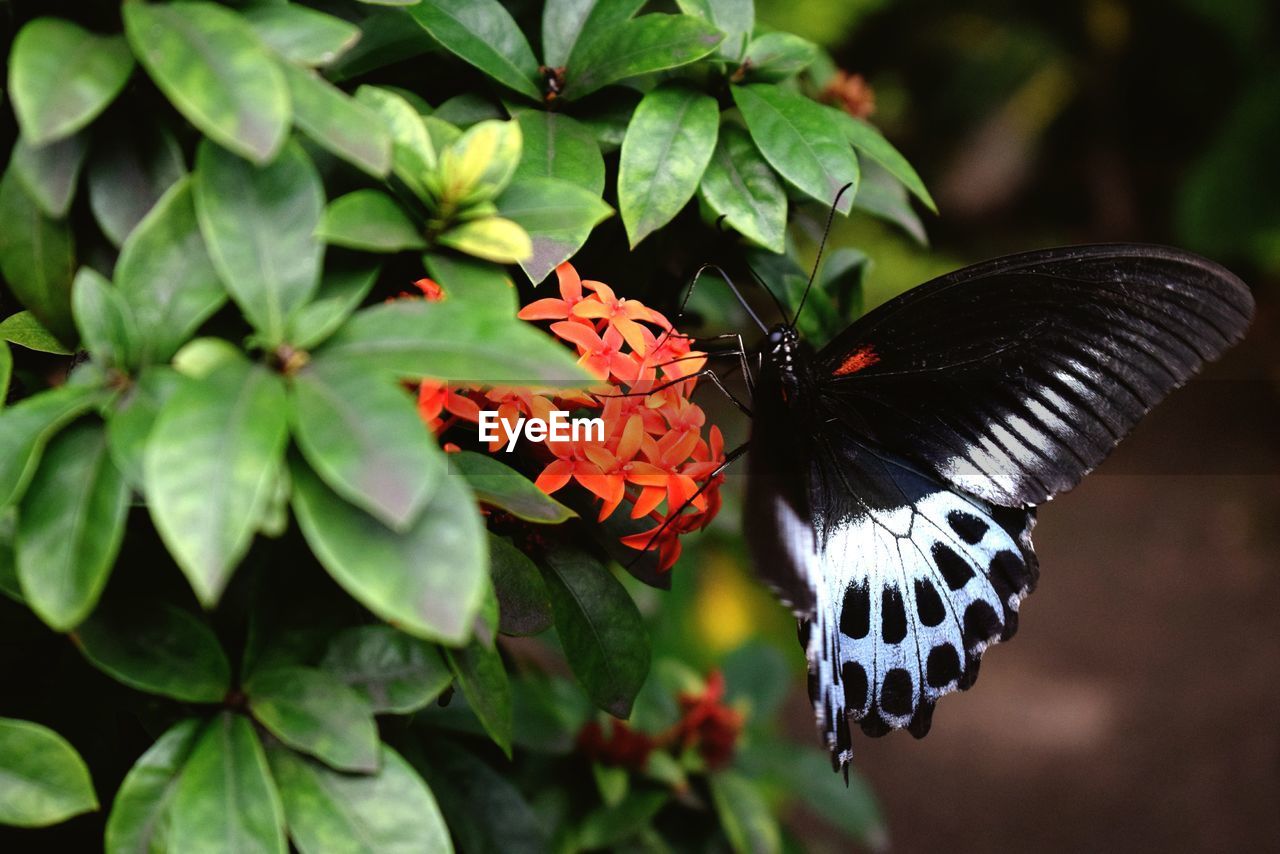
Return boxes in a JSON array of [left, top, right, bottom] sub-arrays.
[[700, 124, 787, 252]]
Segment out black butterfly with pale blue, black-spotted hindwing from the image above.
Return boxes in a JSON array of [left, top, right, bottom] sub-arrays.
[[655, 230, 1253, 768]]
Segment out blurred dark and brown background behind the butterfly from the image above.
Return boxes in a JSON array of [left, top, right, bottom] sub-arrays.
[[660, 0, 1280, 851]]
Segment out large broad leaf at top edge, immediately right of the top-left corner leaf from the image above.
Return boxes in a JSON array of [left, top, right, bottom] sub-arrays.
[[123, 0, 289, 164]]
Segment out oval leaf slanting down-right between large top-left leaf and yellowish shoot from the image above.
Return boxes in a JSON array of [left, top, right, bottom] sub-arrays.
[[282, 64, 392, 178]]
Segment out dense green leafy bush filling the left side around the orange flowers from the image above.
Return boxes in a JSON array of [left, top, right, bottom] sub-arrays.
[[0, 0, 932, 853]]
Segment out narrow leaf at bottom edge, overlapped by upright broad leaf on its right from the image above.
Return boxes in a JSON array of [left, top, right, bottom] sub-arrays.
[[105, 718, 201, 854]]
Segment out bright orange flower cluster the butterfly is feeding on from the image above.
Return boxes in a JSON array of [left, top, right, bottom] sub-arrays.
[[417, 262, 724, 570]]
